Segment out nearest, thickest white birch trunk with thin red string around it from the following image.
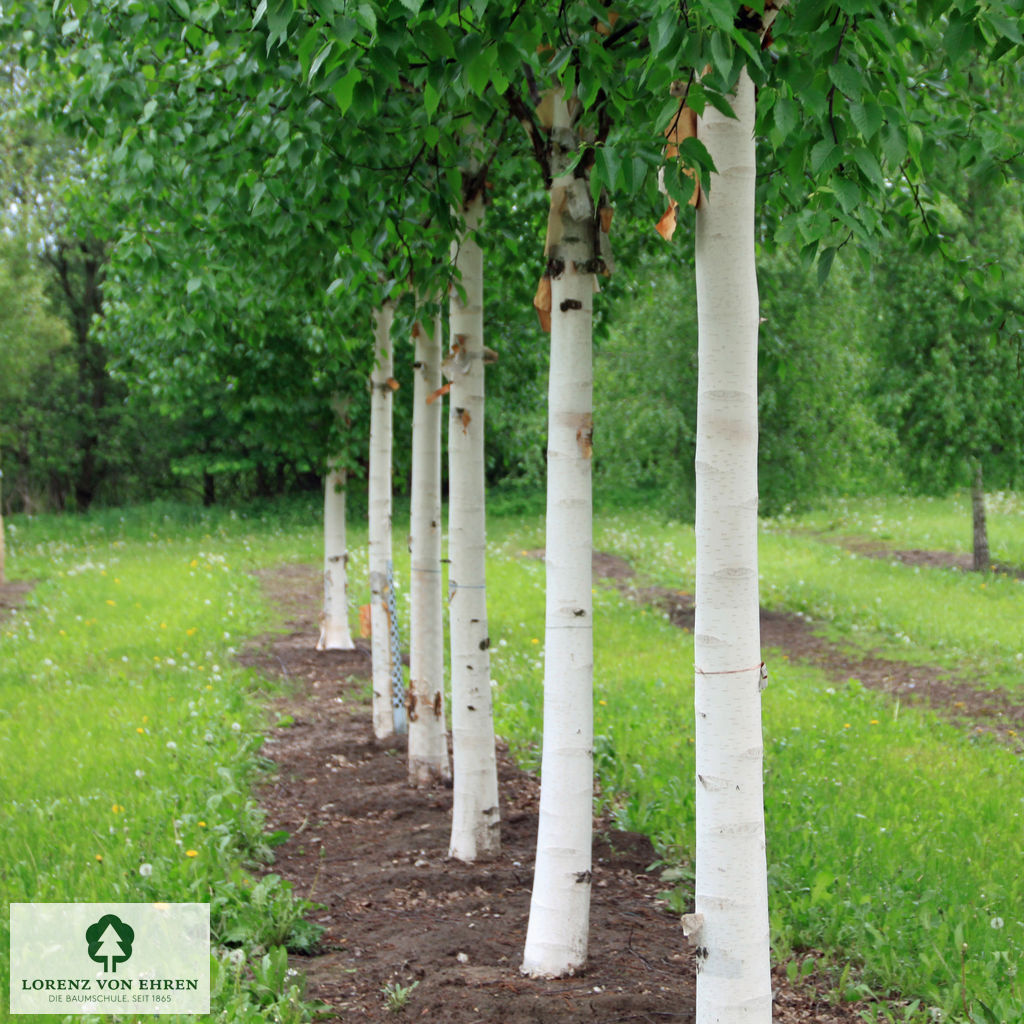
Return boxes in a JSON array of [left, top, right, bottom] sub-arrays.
[[689, 71, 771, 1024]]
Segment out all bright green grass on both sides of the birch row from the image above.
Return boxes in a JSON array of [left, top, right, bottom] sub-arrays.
[[0, 496, 1024, 1022]]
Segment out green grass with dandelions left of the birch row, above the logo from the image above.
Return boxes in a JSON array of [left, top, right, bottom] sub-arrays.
[[0, 505, 319, 1022]]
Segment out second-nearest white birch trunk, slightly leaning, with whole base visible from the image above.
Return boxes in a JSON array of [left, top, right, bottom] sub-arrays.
[[522, 95, 596, 977]]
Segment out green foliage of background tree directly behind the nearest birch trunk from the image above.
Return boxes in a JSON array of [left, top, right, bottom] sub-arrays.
[[595, 253, 896, 518]]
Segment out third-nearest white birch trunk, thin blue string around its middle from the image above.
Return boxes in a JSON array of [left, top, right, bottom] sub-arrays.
[[445, 195, 501, 862]]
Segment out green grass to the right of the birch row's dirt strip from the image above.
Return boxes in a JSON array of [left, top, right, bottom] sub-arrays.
[[488, 506, 1024, 1022]]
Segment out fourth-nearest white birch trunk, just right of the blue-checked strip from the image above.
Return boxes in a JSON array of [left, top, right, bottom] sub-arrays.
[[409, 314, 452, 785]]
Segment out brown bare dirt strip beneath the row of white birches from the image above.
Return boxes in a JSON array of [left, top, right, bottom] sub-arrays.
[[244, 560, 872, 1024]]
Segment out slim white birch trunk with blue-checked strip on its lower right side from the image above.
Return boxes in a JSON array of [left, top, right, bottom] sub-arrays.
[[369, 303, 394, 739]]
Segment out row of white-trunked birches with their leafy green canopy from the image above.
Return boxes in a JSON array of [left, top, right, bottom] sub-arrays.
[[2, 0, 1024, 1021]]
